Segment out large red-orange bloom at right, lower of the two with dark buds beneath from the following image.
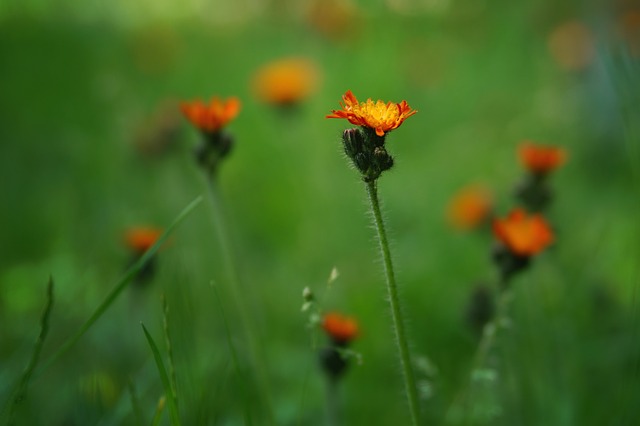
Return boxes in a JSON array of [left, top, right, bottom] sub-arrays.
[[493, 209, 553, 257]]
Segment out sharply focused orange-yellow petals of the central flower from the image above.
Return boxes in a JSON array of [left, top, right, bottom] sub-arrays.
[[326, 90, 418, 137]]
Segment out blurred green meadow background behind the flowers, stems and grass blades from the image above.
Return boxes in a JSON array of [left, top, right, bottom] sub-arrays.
[[0, 0, 640, 425]]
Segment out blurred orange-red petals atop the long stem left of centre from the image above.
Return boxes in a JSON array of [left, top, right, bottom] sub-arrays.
[[180, 96, 240, 133]]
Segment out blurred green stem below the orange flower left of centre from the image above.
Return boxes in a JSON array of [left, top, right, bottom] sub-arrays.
[[208, 174, 275, 425]]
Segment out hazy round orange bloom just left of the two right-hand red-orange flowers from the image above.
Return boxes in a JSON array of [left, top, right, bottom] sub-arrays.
[[447, 185, 493, 229]]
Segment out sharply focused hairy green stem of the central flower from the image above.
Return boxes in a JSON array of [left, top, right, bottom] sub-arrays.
[[367, 180, 419, 426]]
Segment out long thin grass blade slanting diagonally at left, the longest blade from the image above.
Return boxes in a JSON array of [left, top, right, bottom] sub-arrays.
[[37, 196, 202, 374]]
